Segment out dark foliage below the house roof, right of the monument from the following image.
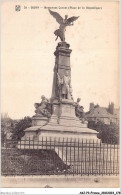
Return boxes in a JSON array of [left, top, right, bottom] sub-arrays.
[[88, 121, 119, 144]]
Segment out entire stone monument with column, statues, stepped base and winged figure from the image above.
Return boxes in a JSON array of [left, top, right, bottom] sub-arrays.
[[22, 10, 98, 140]]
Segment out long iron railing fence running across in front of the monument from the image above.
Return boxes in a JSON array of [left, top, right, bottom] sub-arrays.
[[2, 137, 119, 175]]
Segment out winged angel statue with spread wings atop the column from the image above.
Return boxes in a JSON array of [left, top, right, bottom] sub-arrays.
[[49, 9, 79, 42]]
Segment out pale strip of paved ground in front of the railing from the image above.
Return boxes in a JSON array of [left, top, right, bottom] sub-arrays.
[[1, 175, 120, 188]]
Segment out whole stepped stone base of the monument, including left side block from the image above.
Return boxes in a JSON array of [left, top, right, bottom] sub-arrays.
[[22, 100, 98, 140]]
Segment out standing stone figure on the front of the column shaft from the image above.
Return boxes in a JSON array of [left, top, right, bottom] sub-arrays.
[[57, 72, 73, 100]]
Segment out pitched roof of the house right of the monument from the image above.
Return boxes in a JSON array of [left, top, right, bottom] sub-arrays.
[[86, 107, 116, 118]]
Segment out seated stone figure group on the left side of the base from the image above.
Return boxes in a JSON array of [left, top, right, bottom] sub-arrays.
[[34, 95, 51, 118]]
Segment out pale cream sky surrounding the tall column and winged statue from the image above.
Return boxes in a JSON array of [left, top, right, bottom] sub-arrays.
[[1, 1, 119, 119]]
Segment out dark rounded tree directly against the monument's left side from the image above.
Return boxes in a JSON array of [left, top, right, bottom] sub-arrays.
[[12, 116, 32, 140]]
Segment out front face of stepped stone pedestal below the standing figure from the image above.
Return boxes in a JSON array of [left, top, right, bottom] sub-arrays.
[[38, 100, 97, 140]]
